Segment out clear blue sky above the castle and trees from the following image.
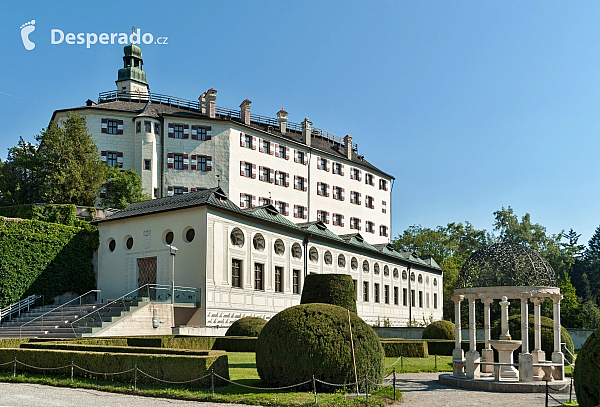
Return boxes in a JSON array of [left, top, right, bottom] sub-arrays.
[[0, 1, 600, 243]]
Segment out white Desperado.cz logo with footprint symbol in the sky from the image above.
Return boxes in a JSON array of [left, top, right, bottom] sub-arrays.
[[20, 20, 169, 51]]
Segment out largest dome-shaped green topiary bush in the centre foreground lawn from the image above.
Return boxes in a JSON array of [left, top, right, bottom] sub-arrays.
[[256, 304, 385, 390]]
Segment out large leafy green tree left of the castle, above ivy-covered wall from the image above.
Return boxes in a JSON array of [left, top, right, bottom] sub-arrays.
[[36, 113, 106, 206]]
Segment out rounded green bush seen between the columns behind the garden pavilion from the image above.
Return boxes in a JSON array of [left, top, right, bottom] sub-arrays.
[[492, 315, 575, 362]]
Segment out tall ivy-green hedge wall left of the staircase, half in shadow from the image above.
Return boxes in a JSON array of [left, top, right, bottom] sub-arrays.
[[0, 217, 98, 307]]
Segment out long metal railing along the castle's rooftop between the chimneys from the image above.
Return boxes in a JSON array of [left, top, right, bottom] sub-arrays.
[[98, 90, 358, 153]]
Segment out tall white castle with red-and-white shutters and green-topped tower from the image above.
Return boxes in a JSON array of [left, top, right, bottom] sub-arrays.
[[52, 44, 394, 244]]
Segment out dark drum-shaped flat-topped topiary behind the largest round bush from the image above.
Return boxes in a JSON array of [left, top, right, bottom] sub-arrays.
[[300, 274, 356, 313]]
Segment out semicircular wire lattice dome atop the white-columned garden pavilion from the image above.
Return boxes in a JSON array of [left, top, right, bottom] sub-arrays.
[[456, 243, 557, 288]]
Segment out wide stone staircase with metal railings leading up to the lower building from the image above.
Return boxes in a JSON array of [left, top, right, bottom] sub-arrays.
[[0, 297, 150, 338]]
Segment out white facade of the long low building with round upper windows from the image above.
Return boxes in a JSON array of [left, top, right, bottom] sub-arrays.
[[98, 191, 443, 327]]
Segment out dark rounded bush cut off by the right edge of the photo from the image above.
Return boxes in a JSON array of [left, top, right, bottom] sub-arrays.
[[573, 328, 600, 407]]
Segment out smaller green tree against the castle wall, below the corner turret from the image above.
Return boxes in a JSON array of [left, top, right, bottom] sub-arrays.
[[102, 167, 150, 209]]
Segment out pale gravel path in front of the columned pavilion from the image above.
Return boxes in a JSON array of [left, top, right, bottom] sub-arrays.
[[396, 373, 575, 407]]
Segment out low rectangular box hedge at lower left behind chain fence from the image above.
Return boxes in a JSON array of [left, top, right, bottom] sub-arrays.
[[0, 348, 229, 387]]
